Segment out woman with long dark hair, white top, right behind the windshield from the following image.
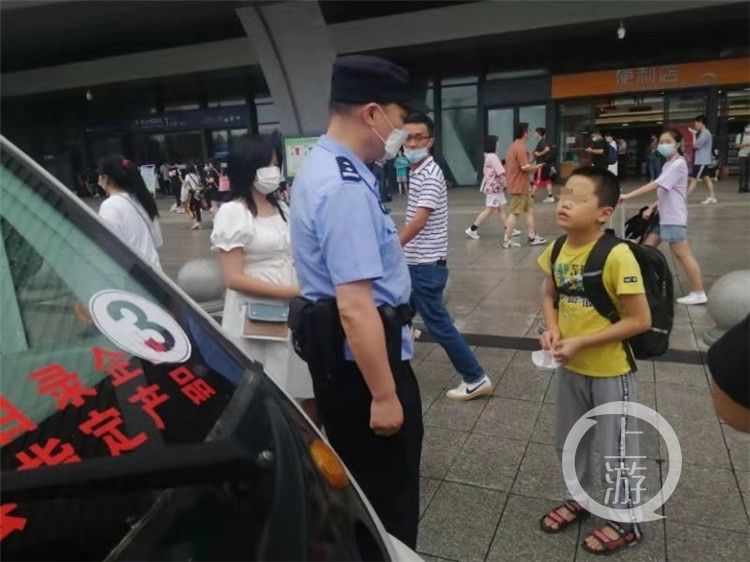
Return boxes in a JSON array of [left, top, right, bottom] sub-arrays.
[[99, 156, 163, 270]]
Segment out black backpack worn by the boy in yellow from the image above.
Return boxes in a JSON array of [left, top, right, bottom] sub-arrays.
[[551, 230, 674, 371]]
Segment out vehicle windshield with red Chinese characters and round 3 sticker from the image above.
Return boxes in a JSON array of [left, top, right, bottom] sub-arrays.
[[0, 139, 394, 560]]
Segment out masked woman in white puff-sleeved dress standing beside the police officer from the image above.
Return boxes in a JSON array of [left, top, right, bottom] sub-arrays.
[[211, 135, 317, 420]]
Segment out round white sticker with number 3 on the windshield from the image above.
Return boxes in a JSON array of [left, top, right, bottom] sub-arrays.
[[89, 289, 191, 363]]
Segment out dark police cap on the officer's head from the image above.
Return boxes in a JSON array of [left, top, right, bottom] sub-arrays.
[[331, 55, 426, 111]]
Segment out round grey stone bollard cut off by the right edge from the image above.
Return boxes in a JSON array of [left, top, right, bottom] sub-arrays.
[[703, 269, 750, 346]]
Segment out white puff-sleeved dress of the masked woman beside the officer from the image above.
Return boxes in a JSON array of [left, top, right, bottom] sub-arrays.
[[211, 200, 315, 399]]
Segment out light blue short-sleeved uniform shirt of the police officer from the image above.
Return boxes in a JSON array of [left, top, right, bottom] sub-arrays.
[[290, 135, 414, 360]]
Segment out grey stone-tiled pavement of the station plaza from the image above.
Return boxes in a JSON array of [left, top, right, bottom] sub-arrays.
[[144, 181, 750, 562]]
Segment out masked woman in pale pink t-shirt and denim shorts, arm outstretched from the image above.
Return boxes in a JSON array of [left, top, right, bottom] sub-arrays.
[[621, 129, 708, 305]]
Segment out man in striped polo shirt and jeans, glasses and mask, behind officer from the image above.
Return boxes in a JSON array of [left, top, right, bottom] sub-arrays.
[[399, 113, 492, 400]]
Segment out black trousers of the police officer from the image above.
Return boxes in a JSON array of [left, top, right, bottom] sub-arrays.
[[310, 361, 424, 548]]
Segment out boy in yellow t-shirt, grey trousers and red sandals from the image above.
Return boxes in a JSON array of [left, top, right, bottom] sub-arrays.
[[539, 167, 651, 554]]
